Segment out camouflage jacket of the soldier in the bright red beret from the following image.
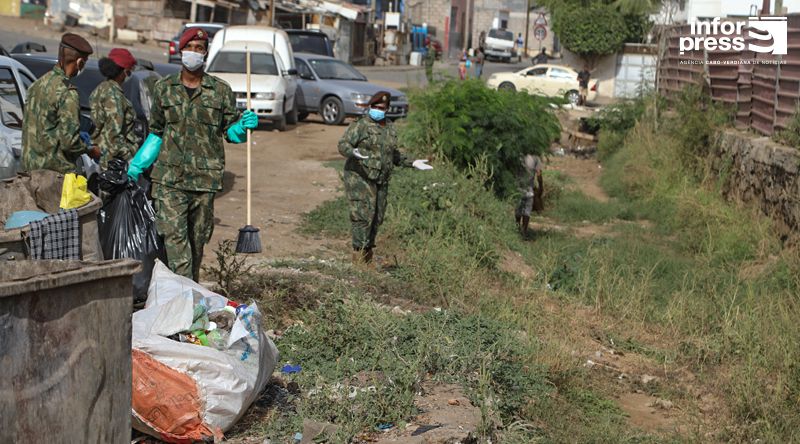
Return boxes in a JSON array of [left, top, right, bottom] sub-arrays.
[[89, 80, 141, 168]]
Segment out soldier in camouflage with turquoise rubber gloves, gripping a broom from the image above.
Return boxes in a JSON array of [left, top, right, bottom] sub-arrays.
[[128, 28, 258, 281]]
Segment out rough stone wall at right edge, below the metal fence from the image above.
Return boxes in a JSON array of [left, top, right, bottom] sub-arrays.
[[711, 130, 800, 234]]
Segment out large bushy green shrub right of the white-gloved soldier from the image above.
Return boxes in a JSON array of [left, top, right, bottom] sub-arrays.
[[401, 80, 561, 196]]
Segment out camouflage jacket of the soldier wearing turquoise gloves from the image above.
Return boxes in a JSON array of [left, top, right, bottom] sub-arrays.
[[150, 73, 239, 192]]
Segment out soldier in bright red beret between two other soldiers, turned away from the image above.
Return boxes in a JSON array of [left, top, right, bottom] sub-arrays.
[[89, 48, 141, 169]]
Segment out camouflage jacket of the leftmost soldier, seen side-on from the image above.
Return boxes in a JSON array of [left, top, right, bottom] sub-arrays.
[[22, 66, 86, 173]]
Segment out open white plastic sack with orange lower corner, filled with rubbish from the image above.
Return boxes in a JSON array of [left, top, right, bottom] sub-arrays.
[[132, 260, 278, 442]]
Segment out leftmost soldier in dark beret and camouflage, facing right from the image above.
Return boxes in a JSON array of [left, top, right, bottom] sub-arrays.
[[22, 33, 100, 174]]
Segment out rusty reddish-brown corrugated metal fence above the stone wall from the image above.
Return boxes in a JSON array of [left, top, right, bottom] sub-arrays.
[[658, 14, 800, 135]]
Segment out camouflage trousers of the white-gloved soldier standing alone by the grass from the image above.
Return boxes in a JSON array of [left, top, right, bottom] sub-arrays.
[[344, 171, 389, 250]]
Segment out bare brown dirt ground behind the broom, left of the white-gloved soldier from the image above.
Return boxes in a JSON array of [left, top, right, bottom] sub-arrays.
[[205, 118, 346, 264]]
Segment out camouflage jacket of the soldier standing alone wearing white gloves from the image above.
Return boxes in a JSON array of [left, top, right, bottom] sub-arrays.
[[339, 117, 411, 183]]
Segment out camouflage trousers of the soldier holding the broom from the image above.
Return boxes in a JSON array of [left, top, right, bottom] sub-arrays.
[[153, 183, 214, 282]]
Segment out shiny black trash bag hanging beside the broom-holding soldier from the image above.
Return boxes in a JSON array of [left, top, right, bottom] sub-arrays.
[[98, 183, 166, 302]]
